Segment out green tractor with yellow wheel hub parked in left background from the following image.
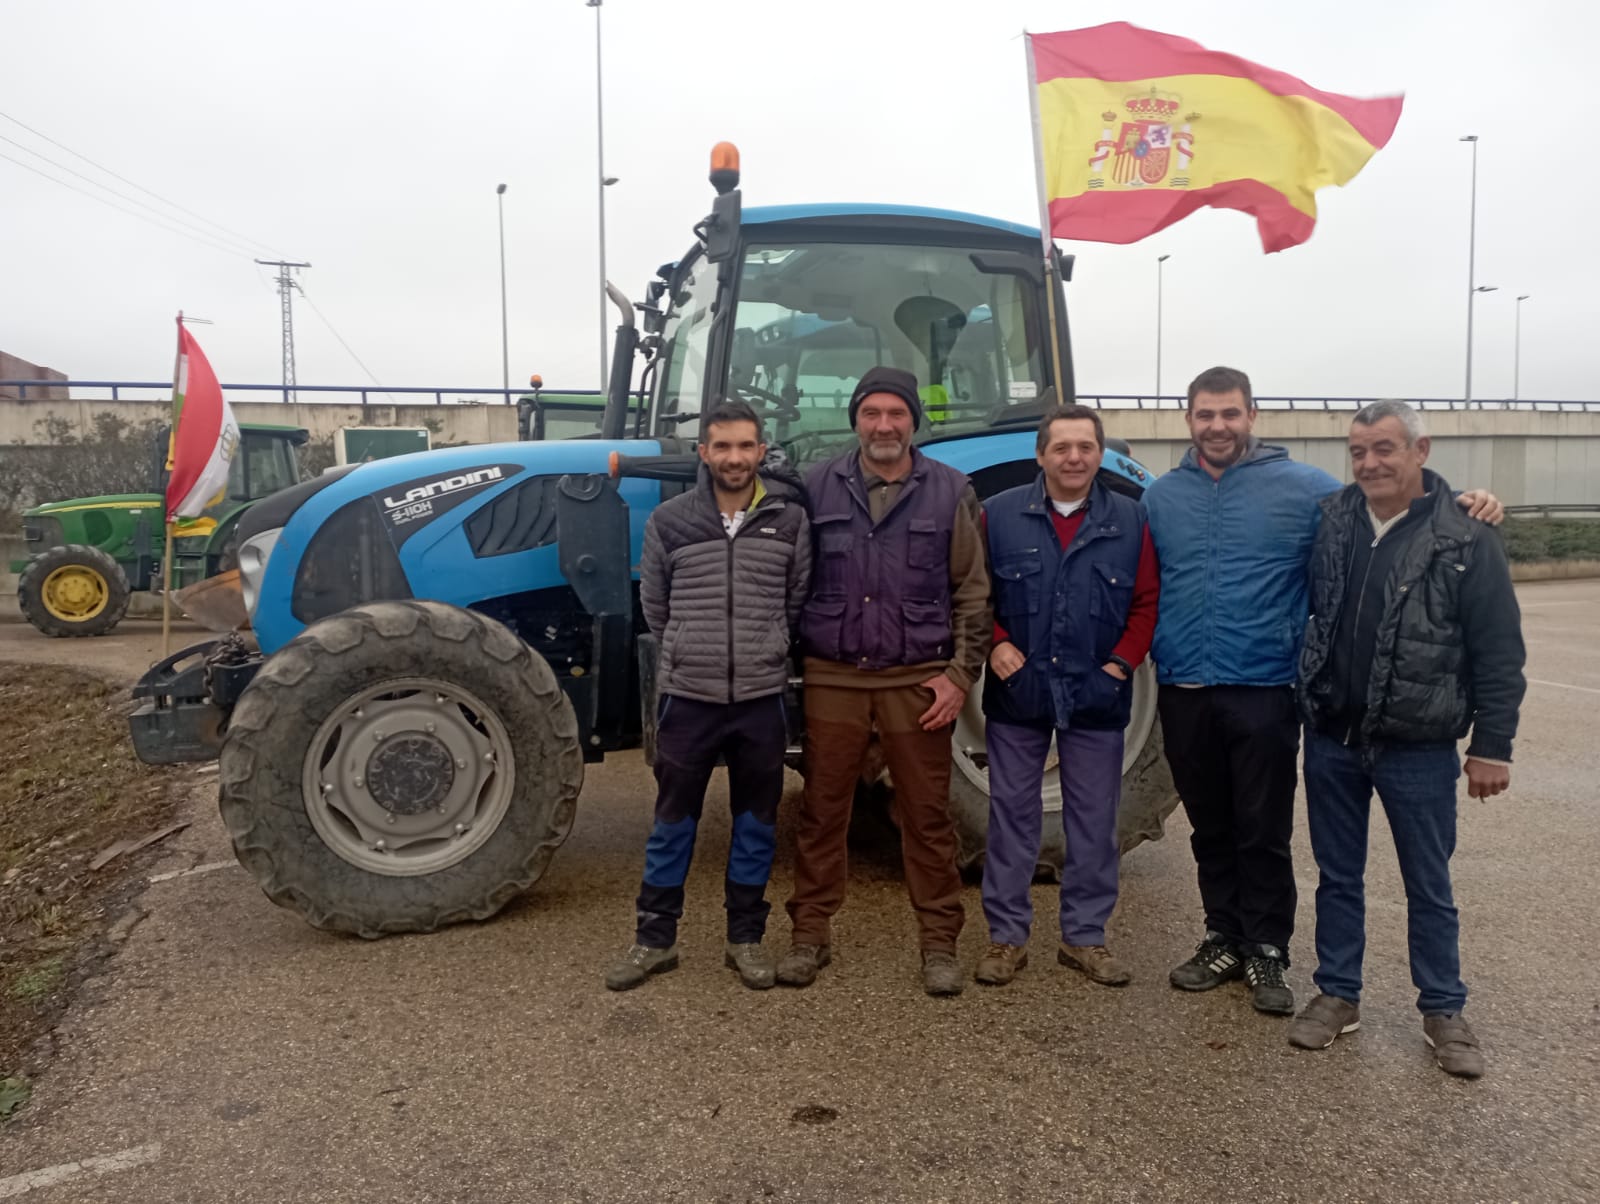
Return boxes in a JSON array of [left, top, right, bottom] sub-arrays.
[[11, 424, 309, 636]]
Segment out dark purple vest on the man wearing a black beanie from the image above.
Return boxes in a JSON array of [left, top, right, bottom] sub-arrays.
[[800, 448, 966, 669]]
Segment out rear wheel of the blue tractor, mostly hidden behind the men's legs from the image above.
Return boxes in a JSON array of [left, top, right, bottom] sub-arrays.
[[950, 663, 1178, 877]]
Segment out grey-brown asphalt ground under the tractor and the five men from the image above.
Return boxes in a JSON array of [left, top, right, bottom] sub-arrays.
[[0, 581, 1600, 1204]]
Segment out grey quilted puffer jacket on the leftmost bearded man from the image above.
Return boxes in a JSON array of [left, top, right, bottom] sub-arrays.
[[638, 469, 811, 703]]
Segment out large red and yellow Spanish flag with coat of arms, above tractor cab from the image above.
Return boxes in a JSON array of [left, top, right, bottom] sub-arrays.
[[1026, 21, 1402, 251]]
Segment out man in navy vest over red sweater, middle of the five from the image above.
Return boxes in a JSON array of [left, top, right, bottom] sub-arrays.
[[976, 405, 1160, 986]]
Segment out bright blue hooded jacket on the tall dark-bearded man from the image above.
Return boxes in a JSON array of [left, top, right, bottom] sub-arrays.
[[1144, 440, 1339, 685]]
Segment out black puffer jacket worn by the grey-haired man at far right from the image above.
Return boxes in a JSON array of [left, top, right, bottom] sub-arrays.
[[1299, 472, 1526, 761]]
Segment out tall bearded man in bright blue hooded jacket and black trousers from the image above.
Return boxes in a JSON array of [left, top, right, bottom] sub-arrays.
[[1144, 368, 1502, 1015]]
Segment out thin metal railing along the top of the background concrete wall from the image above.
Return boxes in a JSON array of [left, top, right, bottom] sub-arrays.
[[0, 381, 1600, 413]]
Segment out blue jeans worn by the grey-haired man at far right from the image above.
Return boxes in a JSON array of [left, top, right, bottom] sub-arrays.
[[1306, 728, 1467, 1015]]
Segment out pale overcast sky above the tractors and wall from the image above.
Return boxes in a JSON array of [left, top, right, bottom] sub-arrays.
[[0, 0, 1600, 399]]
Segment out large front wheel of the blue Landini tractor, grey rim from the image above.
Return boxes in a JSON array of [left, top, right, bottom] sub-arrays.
[[219, 602, 584, 938]]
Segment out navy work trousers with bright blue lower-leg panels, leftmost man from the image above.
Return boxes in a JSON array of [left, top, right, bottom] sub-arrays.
[[635, 693, 789, 949]]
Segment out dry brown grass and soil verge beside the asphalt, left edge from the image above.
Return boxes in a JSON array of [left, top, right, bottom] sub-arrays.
[[0, 663, 184, 1118]]
